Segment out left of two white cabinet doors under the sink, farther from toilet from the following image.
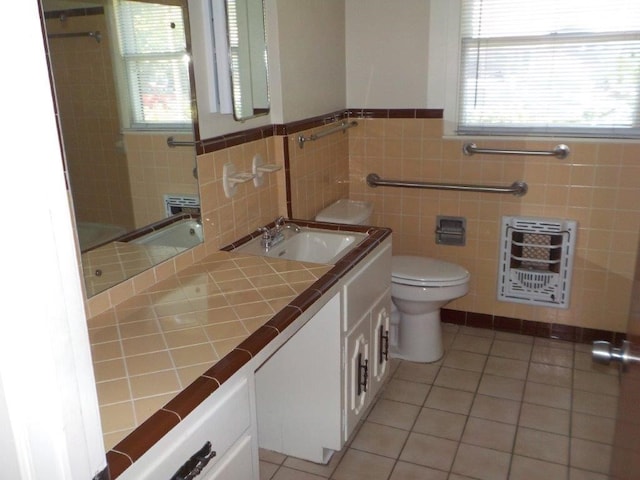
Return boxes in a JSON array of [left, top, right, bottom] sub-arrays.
[[345, 313, 371, 440]]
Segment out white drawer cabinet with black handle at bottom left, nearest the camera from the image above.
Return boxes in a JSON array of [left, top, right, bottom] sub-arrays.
[[118, 370, 259, 480]]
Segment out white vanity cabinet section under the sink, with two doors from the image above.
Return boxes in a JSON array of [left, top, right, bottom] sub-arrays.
[[255, 239, 391, 463]]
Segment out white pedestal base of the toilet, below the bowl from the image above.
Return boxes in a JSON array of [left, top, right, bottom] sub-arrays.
[[391, 309, 444, 363]]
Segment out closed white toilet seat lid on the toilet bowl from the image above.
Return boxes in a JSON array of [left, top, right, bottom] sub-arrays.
[[391, 255, 470, 287]]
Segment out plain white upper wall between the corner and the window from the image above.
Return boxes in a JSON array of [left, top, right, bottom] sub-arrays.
[[345, 0, 435, 108]]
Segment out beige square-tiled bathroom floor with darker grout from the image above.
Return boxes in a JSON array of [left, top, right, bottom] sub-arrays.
[[260, 325, 618, 480]]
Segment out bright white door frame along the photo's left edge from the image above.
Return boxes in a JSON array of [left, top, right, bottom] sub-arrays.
[[0, 2, 106, 480]]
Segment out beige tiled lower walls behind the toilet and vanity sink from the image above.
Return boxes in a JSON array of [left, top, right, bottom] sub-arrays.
[[88, 119, 640, 331]]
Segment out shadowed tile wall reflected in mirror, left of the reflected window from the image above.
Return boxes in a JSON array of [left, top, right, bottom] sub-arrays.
[[46, 15, 134, 229]]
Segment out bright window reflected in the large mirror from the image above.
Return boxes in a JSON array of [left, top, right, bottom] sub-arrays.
[[114, 0, 192, 130]]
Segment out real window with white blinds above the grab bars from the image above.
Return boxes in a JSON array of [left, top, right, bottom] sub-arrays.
[[458, 0, 640, 138]]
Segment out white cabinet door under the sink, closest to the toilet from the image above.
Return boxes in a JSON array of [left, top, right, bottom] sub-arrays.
[[370, 290, 391, 397]]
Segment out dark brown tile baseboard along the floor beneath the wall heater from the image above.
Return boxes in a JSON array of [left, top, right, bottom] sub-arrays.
[[440, 308, 626, 345]]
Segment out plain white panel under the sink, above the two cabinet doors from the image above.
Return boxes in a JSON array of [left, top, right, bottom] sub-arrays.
[[342, 240, 391, 332]]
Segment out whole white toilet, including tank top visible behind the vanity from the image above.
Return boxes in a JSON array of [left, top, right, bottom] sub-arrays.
[[316, 199, 471, 362]]
